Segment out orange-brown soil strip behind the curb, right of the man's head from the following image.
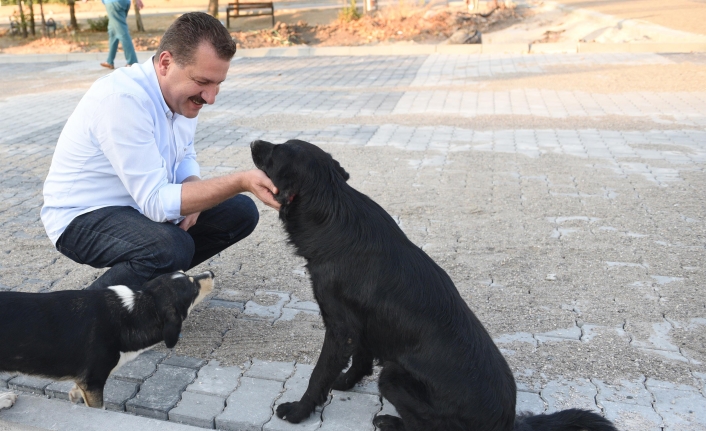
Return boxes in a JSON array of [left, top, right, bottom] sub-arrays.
[[231, 5, 522, 48]]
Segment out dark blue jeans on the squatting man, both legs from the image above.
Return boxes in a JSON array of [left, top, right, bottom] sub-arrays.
[[56, 195, 260, 289]]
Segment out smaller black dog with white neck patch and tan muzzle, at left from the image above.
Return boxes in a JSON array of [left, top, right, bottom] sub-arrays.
[[0, 271, 213, 407]]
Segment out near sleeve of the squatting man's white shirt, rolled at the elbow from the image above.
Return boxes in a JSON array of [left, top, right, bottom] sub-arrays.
[[90, 93, 181, 222]]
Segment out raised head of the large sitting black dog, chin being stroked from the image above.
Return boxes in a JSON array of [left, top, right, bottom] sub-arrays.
[[250, 139, 350, 207]]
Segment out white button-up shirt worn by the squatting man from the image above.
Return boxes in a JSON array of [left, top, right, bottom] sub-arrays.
[[41, 59, 200, 244]]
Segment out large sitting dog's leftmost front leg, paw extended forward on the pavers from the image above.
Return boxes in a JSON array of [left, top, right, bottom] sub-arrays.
[[277, 328, 358, 424]]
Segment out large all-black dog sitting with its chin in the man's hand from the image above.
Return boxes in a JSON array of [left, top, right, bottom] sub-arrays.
[[251, 140, 615, 431]]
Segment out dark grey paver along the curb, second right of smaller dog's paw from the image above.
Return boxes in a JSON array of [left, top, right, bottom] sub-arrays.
[[125, 365, 196, 420]]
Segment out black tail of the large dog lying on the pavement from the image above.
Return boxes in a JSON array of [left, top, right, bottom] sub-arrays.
[[514, 409, 618, 431]]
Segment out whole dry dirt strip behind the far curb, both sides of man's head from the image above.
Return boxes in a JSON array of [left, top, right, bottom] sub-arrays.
[[0, 3, 527, 54]]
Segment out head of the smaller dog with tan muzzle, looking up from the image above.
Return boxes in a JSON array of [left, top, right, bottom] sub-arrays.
[[141, 271, 214, 349]]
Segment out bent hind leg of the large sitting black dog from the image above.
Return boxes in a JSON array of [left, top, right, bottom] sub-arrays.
[[373, 362, 440, 431]]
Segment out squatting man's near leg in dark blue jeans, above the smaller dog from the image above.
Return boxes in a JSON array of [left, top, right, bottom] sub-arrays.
[[56, 207, 194, 289]]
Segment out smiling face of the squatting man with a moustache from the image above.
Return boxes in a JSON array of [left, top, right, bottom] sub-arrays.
[[155, 42, 230, 118]]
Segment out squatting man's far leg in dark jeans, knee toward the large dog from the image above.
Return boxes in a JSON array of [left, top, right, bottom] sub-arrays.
[[187, 195, 260, 268]]
